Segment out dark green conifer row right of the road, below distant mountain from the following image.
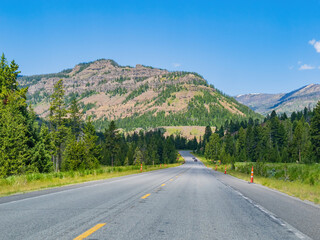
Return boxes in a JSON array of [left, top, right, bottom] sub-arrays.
[[197, 107, 320, 164]]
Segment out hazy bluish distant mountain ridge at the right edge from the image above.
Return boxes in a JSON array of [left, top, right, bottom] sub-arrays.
[[235, 84, 320, 115]]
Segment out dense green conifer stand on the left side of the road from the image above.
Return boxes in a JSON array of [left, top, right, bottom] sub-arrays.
[[0, 55, 177, 177]]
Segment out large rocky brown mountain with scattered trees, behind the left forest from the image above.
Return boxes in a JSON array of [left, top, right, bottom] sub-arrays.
[[18, 59, 261, 129]]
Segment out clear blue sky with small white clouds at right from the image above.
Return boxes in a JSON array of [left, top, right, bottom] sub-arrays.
[[0, 0, 320, 95]]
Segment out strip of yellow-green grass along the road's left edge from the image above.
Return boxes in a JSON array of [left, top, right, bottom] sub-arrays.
[[0, 160, 183, 197]]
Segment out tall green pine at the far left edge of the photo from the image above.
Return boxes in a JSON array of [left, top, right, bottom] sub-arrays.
[[0, 54, 33, 176]]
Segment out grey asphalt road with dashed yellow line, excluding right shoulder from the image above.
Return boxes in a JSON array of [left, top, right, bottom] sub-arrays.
[[0, 151, 319, 240]]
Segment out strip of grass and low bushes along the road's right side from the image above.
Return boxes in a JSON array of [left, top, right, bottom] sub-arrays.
[[196, 155, 320, 204]]
